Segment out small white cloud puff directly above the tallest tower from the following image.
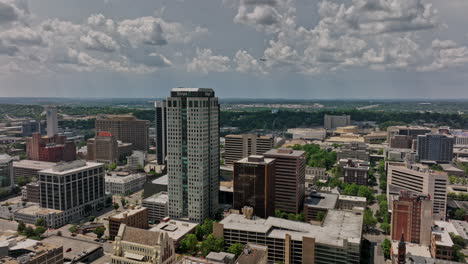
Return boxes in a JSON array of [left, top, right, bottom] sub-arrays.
[[187, 48, 231, 74]]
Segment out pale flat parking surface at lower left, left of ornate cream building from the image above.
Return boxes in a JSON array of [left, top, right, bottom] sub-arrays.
[[42, 235, 102, 260]]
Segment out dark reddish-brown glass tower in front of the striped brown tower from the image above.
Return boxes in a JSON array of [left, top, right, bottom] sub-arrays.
[[233, 155, 275, 218]]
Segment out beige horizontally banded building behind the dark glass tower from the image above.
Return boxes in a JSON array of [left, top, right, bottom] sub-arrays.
[[224, 134, 274, 165]]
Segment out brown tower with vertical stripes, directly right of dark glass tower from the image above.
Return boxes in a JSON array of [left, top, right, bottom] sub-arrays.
[[263, 148, 305, 214]]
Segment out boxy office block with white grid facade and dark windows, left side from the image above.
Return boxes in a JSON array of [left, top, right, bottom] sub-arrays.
[[39, 160, 105, 223]]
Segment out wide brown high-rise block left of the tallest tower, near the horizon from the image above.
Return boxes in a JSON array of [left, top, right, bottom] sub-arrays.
[[96, 116, 149, 151]]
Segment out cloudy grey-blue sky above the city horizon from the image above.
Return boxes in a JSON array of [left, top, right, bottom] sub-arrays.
[[0, 0, 468, 99]]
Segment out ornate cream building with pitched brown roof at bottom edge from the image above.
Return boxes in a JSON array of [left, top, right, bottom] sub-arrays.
[[111, 224, 176, 264]]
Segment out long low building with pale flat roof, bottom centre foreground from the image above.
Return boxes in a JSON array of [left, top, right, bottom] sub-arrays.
[[213, 210, 363, 264]]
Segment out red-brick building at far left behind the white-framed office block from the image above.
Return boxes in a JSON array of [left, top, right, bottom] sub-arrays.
[[26, 133, 76, 162]]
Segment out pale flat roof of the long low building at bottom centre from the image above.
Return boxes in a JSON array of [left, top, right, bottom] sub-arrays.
[[220, 209, 363, 247]]
